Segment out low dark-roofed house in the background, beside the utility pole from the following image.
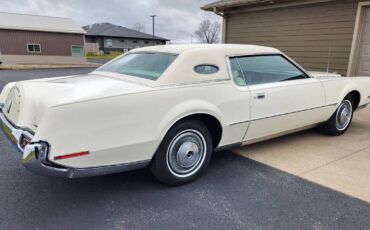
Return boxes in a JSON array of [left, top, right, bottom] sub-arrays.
[[83, 23, 169, 53]]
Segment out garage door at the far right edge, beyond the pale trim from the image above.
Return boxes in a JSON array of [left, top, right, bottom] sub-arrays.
[[356, 7, 370, 76]]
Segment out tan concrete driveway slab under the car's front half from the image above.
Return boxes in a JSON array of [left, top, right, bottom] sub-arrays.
[[233, 108, 370, 202]]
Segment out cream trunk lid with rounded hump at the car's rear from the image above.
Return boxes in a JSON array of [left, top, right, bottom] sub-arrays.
[[2, 74, 152, 131]]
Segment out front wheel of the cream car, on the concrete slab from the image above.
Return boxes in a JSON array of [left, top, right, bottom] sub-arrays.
[[323, 96, 354, 136]]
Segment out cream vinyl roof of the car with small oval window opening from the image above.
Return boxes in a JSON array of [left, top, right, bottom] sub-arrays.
[[95, 44, 281, 87]]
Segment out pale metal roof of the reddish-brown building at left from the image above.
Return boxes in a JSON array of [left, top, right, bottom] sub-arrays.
[[0, 12, 86, 34]]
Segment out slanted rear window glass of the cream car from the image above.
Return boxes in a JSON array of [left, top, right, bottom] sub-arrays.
[[98, 53, 177, 81]]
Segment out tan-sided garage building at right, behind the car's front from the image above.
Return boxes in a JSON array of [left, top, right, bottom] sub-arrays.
[[202, 0, 370, 76]]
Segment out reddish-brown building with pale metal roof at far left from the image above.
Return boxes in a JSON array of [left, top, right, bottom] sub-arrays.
[[0, 13, 86, 64]]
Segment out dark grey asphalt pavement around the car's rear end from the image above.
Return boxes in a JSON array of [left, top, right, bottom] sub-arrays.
[[0, 69, 370, 230]]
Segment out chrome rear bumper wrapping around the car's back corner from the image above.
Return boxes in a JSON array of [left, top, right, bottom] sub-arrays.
[[0, 105, 150, 178]]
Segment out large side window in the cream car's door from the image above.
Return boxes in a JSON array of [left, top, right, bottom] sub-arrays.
[[238, 55, 308, 85]]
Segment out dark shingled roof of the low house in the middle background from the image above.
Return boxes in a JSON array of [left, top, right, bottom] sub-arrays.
[[83, 23, 169, 41]]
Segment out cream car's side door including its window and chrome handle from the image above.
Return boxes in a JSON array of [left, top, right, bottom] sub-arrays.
[[230, 54, 325, 142]]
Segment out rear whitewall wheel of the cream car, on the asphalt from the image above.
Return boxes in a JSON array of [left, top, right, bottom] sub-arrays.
[[150, 119, 213, 185]]
